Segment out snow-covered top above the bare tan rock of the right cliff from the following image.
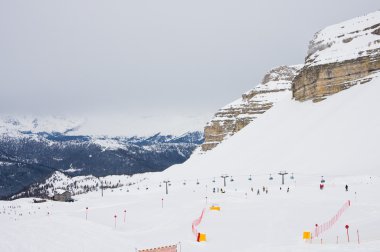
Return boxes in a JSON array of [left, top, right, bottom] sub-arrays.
[[306, 11, 380, 65]]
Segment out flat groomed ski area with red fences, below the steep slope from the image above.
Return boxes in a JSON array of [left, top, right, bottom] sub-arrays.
[[0, 174, 380, 251]]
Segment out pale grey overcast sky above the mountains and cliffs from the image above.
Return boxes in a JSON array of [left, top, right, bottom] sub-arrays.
[[0, 0, 380, 135]]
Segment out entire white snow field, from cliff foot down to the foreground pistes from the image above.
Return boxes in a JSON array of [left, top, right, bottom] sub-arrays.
[[0, 75, 380, 252]]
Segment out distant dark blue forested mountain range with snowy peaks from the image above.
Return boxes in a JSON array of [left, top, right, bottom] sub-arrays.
[[0, 116, 203, 198]]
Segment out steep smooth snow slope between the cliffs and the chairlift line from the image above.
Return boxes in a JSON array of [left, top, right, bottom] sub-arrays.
[[164, 71, 380, 178]]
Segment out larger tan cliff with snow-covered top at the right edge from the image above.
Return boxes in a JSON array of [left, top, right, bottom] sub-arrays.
[[292, 11, 380, 102]]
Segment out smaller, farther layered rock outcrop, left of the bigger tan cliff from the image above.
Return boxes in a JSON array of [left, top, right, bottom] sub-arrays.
[[202, 65, 301, 151]]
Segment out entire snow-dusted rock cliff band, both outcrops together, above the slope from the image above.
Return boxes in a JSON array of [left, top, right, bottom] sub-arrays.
[[202, 11, 380, 151]]
